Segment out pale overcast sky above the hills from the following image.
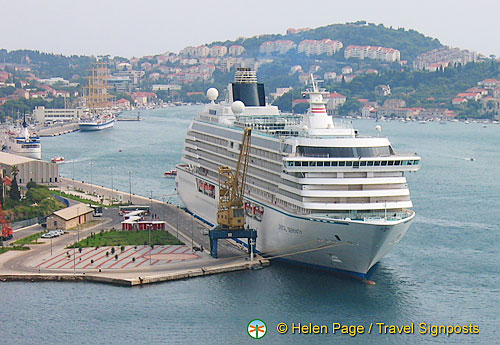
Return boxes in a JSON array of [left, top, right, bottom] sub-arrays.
[[0, 0, 500, 58]]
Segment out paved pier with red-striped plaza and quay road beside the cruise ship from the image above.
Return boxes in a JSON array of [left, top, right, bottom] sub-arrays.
[[0, 178, 269, 286]]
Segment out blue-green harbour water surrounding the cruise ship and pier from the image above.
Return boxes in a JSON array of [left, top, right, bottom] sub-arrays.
[[0, 111, 500, 344]]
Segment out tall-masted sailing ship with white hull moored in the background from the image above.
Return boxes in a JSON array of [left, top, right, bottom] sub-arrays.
[[79, 61, 115, 131]]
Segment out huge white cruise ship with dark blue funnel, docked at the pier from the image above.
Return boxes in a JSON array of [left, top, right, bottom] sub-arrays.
[[176, 68, 420, 279]]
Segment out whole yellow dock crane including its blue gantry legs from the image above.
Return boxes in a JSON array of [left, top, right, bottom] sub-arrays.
[[209, 127, 257, 259]]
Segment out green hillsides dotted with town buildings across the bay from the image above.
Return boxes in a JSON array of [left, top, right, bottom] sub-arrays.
[[0, 22, 500, 122]]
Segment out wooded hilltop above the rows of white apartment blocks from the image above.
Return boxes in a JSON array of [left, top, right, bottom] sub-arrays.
[[209, 21, 443, 61]]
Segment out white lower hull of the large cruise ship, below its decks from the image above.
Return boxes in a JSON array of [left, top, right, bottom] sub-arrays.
[[176, 167, 414, 278]]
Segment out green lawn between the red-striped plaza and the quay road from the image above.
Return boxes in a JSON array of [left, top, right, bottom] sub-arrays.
[[68, 230, 184, 248]]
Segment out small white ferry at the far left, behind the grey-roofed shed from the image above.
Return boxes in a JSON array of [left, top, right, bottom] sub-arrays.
[[3, 117, 42, 159]]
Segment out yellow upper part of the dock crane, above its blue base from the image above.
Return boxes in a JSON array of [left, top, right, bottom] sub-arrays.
[[217, 127, 252, 230]]
